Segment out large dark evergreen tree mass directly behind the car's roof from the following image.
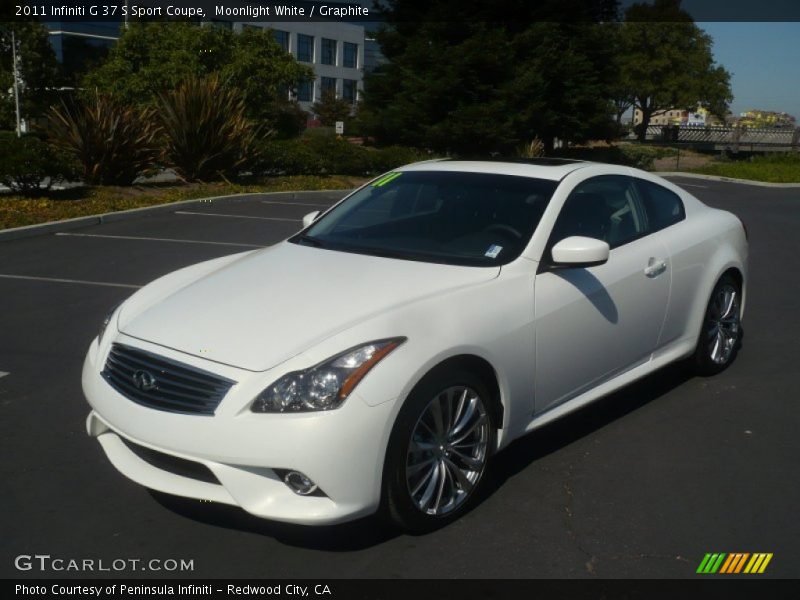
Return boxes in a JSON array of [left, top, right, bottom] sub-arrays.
[[361, 0, 615, 155]]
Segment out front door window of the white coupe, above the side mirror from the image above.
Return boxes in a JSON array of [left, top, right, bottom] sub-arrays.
[[550, 175, 649, 248]]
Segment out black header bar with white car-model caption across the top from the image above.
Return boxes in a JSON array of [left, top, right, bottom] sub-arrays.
[[0, 0, 800, 23]]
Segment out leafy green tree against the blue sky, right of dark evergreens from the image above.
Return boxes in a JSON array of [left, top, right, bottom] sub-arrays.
[[618, 0, 733, 140]]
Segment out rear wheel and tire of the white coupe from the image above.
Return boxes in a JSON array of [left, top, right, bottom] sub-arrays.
[[692, 274, 742, 376]]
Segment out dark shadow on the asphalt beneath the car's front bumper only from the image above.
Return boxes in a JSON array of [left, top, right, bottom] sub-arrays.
[[148, 490, 399, 552]]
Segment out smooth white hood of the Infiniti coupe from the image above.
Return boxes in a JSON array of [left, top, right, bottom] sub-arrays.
[[119, 242, 500, 371]]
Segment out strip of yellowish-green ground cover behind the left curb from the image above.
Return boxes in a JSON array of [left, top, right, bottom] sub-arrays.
[[0, 175, 365, 229]]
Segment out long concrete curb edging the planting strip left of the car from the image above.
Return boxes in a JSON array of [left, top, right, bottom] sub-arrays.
[[0, 190, 352, 242]]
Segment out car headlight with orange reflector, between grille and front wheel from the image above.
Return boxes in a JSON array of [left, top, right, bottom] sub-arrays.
[[250, 338, 406, 413]]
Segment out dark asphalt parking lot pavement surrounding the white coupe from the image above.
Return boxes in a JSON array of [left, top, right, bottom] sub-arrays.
[[0, 178, 800, 578]]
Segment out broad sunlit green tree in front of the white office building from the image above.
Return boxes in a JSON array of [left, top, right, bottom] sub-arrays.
[[83, 22, 311, 125]]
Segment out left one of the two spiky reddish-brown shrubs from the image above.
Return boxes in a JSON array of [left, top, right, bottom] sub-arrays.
[[47, 94, 160, 185]]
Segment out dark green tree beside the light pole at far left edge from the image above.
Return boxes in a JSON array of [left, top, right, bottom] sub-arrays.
[[0, 22, 62, 129]]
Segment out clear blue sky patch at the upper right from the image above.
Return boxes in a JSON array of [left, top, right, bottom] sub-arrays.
[[698, 22, 800, 120]]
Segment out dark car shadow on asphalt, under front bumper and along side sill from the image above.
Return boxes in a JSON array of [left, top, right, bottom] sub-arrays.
[[150, 363, 693, 552]]
